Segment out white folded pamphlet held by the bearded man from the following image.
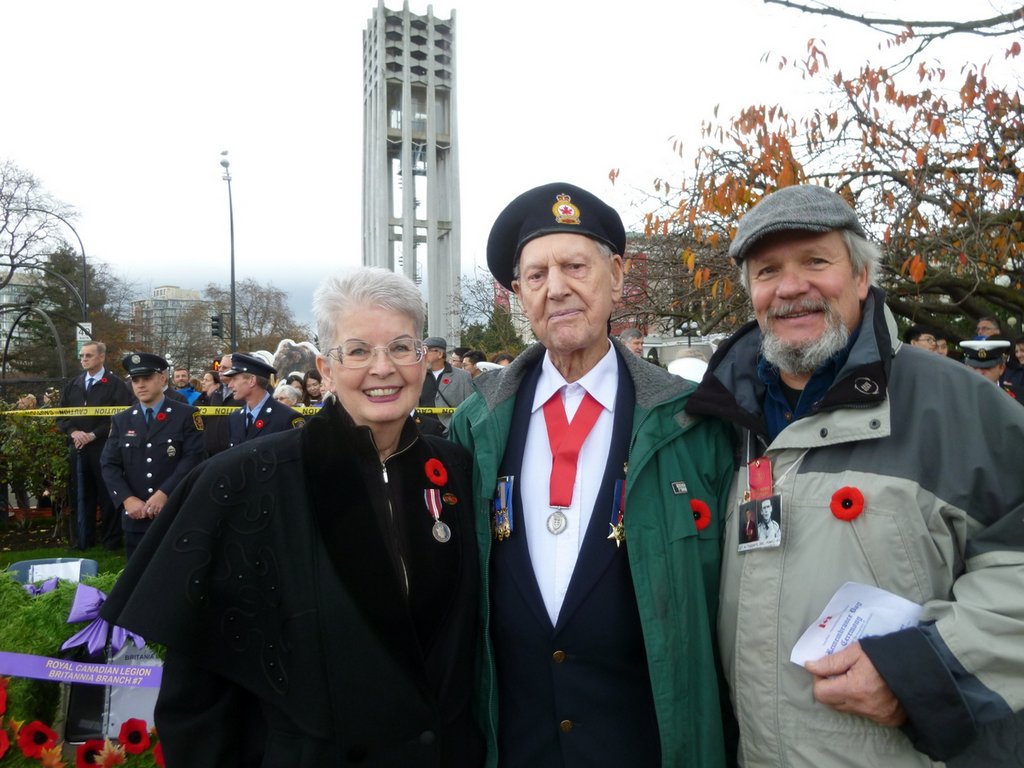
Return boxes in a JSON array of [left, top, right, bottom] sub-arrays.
[[790, 582, 922, 667]]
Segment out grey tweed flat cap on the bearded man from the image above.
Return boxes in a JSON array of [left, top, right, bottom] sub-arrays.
[[729, 184, 867, 264]]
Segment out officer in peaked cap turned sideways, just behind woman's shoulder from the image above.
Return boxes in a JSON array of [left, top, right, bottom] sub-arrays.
[[220, 352, 306, 446]]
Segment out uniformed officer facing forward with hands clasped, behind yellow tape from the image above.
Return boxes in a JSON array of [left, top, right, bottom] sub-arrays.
[[100, 352, 206, 558]]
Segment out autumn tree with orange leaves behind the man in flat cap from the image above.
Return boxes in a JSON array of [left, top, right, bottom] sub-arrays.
[[634, 0, 1024, 338]]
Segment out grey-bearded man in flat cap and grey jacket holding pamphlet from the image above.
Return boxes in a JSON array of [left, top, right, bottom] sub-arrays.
[[687, 185, 1024, 768]]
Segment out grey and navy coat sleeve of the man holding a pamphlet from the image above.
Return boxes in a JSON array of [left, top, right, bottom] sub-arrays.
[[861, 388, 1024, 760]]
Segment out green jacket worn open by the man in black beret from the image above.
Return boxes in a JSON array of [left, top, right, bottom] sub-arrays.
[[451, 340, 733, 768]]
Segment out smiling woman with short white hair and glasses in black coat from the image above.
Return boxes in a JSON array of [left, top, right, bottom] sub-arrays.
[[102, 268, 484, 768]]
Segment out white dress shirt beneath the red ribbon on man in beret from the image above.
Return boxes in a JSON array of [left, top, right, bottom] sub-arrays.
[[516, 344, 618, 625]]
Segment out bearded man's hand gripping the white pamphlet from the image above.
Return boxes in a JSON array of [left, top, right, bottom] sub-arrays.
[[804, 643, 906, 727]]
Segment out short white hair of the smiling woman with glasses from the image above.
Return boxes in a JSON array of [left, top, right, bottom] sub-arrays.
[[313, 266, 427, 349]]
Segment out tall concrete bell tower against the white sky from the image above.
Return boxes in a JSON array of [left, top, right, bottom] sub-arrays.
[[362, 0, 461, 344]]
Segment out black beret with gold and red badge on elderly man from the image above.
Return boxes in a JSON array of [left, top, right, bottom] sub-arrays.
[[487, 182, 626, 291]]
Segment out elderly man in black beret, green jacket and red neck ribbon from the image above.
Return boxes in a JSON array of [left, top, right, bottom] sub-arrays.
[[452, 183, 732, 768]]
